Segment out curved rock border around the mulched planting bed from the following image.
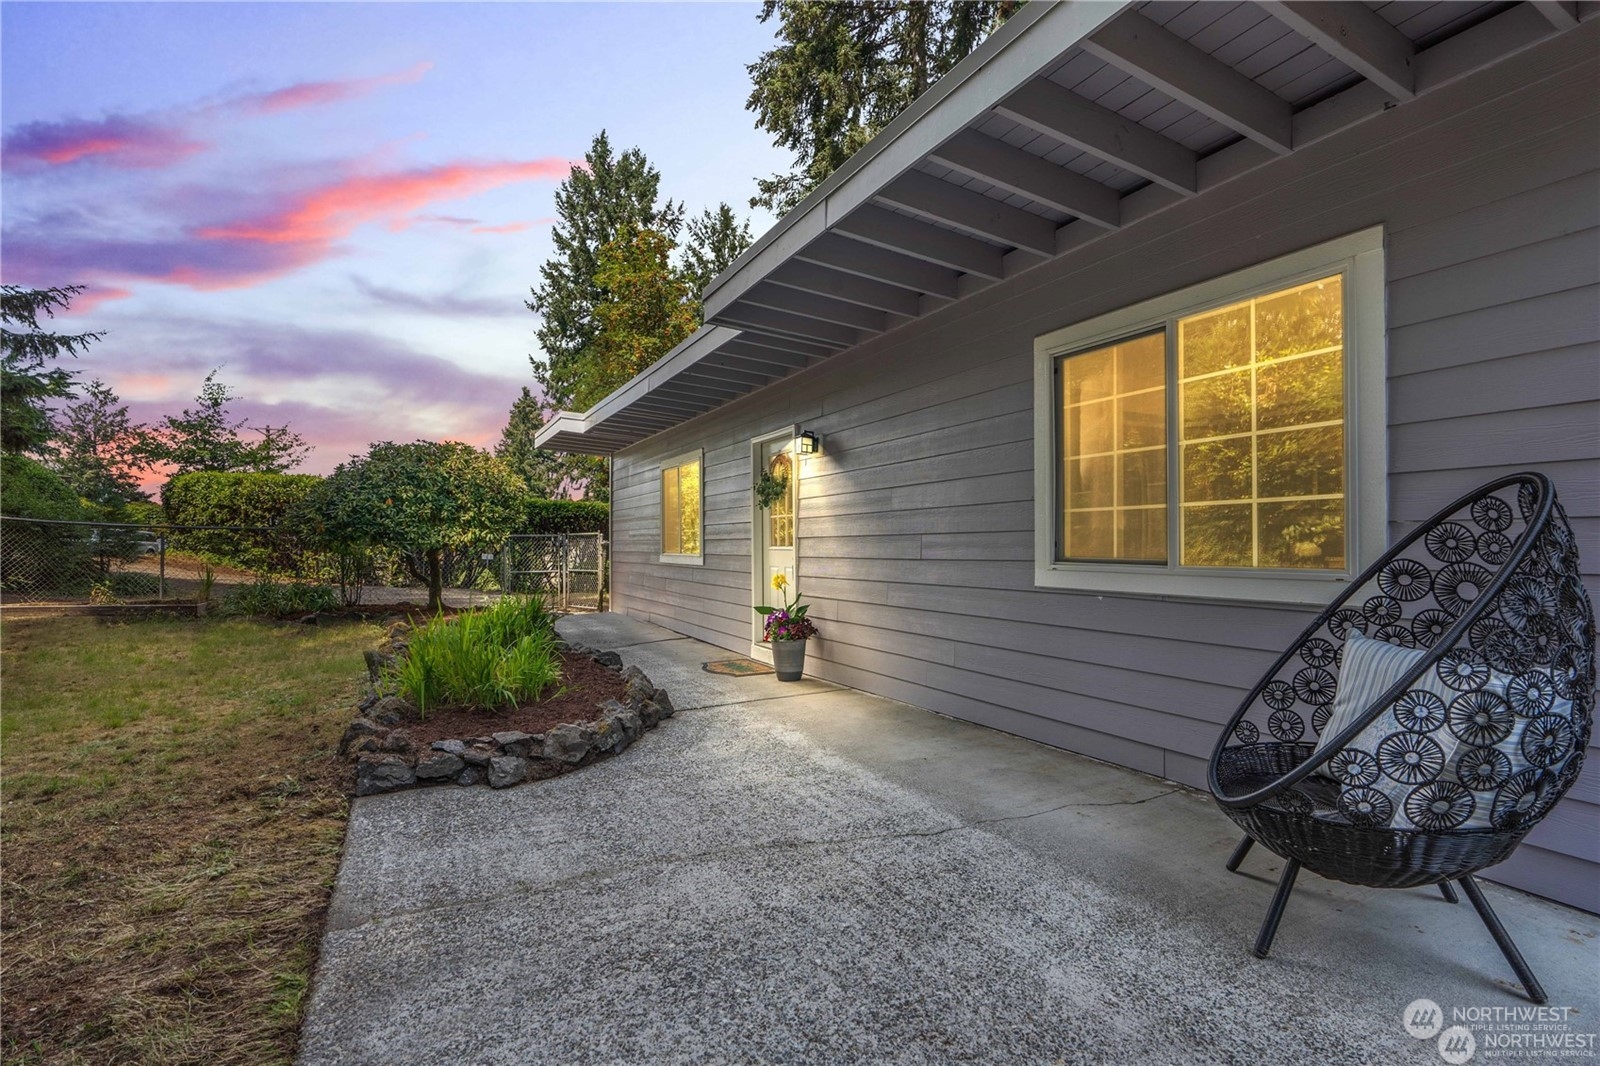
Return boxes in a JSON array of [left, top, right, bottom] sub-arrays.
[[339, 623, 675, 795]]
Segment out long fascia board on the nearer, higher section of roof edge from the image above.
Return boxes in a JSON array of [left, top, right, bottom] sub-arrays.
[[704, 0, 1131, 320]]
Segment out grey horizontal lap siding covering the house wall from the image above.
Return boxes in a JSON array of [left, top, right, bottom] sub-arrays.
[[613, 33, 1600, 909]]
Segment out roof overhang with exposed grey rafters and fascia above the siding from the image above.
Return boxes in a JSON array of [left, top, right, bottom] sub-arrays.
[[538, 0, 1600, 455]]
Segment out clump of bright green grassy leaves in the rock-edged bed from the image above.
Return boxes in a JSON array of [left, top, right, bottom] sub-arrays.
[[395, 595, 562, 715]]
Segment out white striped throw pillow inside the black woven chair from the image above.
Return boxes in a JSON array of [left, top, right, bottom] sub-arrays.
[[1312, 632, 1573, 832]]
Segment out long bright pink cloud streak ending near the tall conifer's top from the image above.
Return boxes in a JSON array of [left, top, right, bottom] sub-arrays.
[[197, 157, 573, 245]]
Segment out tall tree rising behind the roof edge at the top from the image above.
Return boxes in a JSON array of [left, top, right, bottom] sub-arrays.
[[746, 0, 1022, 213]]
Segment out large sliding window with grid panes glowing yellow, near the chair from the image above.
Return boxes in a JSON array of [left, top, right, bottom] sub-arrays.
[[1035, 230, 1384, 603]]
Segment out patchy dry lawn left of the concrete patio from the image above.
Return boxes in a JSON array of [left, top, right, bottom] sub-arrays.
[[0, 618, 379, 1064]]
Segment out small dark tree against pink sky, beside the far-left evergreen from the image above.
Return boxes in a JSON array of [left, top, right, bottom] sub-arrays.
[[45, 378, 150, 519]]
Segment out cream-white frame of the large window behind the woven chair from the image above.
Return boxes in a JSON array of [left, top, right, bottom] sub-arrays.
[[1034, 226, 1389, 607]]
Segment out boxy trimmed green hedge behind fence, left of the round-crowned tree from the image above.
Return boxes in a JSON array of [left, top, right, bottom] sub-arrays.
[[162, 471, 322, 570]]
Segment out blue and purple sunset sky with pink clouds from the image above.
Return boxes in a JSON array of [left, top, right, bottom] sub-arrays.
[[0, 3, 787, 472]]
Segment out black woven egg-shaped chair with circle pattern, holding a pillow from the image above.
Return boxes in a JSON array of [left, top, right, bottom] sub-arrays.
[[1210, 474, 1595, 1004]]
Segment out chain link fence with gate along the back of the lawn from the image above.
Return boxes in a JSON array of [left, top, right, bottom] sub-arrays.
[[0, 517, 606, 613]]
